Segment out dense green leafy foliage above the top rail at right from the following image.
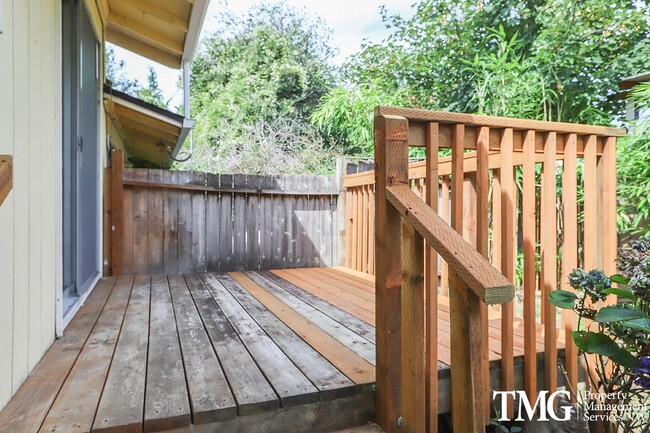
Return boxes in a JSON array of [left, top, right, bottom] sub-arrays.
[[327, 0, 650, 148]]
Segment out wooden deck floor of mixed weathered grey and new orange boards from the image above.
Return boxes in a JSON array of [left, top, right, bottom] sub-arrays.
[[0, 268, 560, 433]]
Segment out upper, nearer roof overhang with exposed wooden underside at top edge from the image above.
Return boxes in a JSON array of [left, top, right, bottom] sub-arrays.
[[106, 0, 209, 69]]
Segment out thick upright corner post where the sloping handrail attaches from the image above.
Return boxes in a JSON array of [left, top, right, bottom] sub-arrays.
[[375, 115, 408, 433]]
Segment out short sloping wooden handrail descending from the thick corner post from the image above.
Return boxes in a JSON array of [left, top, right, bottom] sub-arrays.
[[386, 185, 515, 304]]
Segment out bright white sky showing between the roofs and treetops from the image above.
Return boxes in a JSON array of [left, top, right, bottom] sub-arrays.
[[109, 0, 414, 107]]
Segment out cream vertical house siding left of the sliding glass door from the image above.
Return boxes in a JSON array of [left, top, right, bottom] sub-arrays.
[[0, 0, 62, 408]]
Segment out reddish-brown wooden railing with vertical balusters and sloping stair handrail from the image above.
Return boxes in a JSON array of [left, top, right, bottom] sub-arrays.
[[370, 107, 625, 432]]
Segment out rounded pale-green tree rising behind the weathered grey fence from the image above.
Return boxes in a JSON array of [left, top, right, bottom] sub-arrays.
[[185, 2, 334, 172]]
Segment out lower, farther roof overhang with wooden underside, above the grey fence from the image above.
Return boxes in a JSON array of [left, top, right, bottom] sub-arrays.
[[104, 86, 194, 168]]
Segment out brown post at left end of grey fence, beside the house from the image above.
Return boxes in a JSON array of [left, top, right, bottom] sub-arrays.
[[111, 150, 124, 276]]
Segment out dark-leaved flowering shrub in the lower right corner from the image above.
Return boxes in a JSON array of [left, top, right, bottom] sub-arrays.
[[549, 238, 650, 432]]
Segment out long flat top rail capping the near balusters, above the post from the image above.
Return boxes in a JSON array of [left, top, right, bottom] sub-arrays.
[[375, 106, 627, 137]]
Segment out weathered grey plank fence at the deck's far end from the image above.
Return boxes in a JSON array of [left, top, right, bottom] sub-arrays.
[[104, 151, 339, 275]]
